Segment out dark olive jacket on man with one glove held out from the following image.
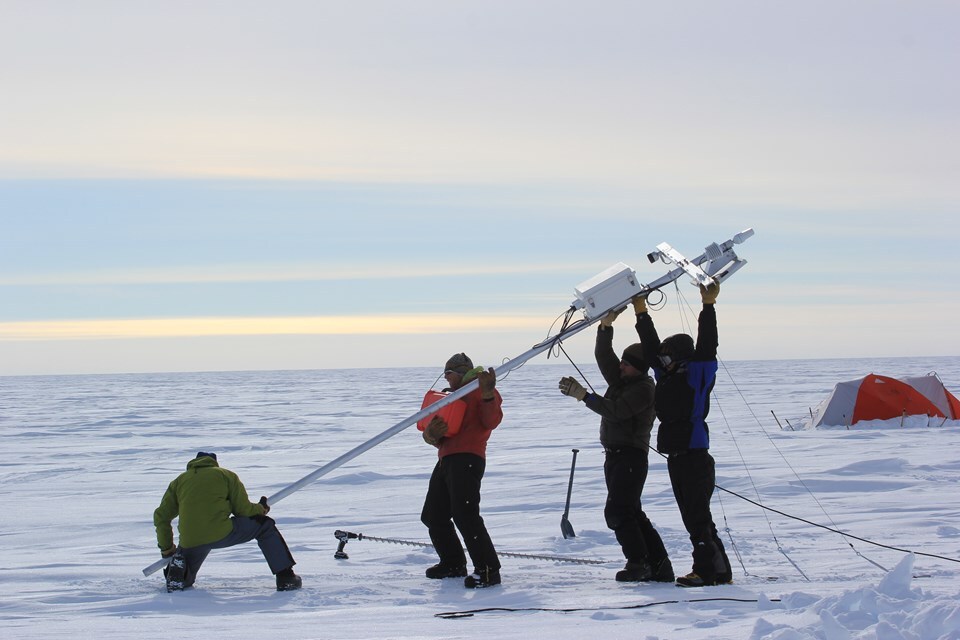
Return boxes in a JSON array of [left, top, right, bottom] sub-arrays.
[[583, 327, 654, 454]]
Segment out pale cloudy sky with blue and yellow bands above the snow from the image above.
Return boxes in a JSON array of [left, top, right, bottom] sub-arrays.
[[0, 0, 960, 375]]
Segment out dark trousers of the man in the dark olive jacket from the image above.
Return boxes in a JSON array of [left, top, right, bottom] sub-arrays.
[[603, 447, 667, 567]]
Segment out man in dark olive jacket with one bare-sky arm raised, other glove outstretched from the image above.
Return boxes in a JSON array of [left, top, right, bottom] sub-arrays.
[[560, 312, 674, 582]]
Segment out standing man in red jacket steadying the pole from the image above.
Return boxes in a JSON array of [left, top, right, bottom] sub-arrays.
[[420, 353, 503, 589]]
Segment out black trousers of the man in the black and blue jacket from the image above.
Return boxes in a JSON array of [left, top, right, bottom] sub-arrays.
[[667, 449, 733, 581]]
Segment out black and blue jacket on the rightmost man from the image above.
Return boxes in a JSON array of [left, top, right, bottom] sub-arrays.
[[637, 304, 719, 454]]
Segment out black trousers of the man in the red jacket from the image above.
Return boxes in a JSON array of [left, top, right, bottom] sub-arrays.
[[420, 453, 500, 570]]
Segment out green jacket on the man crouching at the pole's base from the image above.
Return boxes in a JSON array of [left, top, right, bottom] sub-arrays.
[[153, 456, 264, 551]]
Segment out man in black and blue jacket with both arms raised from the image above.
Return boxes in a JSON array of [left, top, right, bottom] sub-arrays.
[[633, 284, 733, 587]]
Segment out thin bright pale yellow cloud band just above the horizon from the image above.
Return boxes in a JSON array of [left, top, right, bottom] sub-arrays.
[[0, 315, 550, 341]]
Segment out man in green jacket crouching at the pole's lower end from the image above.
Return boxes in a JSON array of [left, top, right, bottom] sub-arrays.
[[153, 451, 302, 592]]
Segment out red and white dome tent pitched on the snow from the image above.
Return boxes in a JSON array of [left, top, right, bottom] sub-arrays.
[[812, 373, 960, 427]]
